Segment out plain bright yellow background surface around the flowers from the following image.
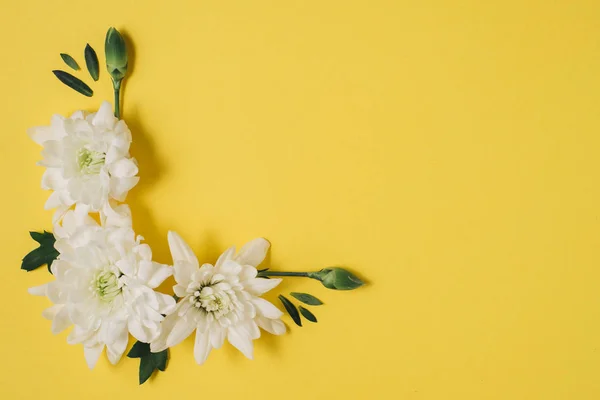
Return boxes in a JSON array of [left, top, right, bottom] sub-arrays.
[[0, 0, 600, 400]]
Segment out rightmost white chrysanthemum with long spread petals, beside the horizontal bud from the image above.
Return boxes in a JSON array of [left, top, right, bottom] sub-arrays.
[[150, 232, 285, 364]]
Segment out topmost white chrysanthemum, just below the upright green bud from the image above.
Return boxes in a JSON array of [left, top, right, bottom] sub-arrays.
[[28, 101, 139, 217]]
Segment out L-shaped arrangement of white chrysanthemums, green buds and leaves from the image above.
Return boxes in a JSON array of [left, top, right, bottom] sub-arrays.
[[21, 28, 363, 384]]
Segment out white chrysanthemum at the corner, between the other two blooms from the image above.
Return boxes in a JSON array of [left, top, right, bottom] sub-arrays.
[[30, 212, 175, 368]]
